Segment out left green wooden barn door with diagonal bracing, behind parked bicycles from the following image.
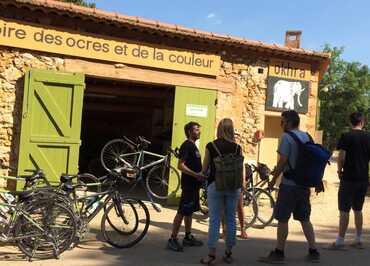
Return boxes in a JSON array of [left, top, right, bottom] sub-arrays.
[[18, 70, 85, 187]]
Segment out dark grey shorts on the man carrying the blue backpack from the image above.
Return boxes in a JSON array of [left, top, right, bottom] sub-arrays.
[[274, 184, 311, 223]]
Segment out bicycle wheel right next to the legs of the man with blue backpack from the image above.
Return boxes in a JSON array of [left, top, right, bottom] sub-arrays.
[[254, 188, 275, 227]]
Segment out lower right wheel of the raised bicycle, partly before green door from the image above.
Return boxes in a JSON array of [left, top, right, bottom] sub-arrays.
[[146, 164, 180, 199]]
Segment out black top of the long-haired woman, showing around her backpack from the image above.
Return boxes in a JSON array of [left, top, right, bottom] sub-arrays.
[[206, 139, 242, 185]]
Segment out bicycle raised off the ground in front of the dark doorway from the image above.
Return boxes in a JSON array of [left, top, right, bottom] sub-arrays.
[[100, 136, 180, 212]]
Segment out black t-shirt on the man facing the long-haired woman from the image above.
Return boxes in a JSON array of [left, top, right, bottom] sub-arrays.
[[179, 140, 202, 190]]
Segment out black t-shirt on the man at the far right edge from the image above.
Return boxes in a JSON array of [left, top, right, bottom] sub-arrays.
[[337, 130, 370, 182]]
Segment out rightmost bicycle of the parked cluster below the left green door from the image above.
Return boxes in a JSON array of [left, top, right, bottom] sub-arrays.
[[60, 172, 150, 248]]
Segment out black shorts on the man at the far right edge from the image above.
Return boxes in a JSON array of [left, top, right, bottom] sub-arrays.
[[338, 181, 369, 212]]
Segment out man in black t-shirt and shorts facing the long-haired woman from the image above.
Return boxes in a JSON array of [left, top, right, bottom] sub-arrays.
[[167, 122, 204, 251]]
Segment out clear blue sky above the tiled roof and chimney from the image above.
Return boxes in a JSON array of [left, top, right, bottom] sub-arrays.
[[93, 0, 370, 66]]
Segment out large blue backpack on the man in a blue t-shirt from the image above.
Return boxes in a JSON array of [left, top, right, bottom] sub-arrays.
[[284, 131, 331, 187]]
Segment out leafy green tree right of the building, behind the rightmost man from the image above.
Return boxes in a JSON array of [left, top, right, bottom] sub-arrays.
[[319, 45, 370, 150]]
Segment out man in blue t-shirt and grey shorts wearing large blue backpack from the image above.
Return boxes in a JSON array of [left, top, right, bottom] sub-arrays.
[[259, 110, 330, 264]]
